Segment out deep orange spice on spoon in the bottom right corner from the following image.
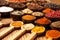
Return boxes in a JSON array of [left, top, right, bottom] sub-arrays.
[[46, 30, 60, 38]]
